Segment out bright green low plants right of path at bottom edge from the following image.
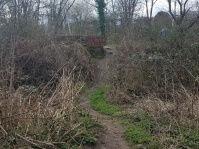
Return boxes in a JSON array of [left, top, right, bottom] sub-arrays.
[[121, 114, 166, 149]]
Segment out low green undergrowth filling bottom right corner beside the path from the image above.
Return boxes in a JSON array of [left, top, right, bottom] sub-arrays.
[[122, 114, 199, 149]]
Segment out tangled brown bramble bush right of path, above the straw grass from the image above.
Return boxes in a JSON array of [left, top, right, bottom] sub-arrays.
[[110, 24, 199, 103]]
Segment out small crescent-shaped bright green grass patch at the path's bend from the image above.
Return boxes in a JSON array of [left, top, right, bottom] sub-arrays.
[[90, 87, 121, 117]]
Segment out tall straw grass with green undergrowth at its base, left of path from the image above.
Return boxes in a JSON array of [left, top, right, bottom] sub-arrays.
[[0, 76, 102, 149]]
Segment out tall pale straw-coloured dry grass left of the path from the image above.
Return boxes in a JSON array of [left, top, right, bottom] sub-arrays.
[[0, 71, 70, 143]]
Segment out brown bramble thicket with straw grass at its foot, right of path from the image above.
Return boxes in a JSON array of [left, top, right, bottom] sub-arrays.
[[110, 28, 198, 120]]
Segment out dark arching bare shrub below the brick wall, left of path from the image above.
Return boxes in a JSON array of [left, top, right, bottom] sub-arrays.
[[12, 38, 94, 86]]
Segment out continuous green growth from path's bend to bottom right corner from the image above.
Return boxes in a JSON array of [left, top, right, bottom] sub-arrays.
[[89, 87, 199, 149]]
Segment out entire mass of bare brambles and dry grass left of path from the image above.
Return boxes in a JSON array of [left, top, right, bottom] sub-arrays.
[[0, 37, 96, 148]]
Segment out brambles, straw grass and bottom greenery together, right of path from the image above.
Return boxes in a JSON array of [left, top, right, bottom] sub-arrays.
[[109, 32, 199, 149]]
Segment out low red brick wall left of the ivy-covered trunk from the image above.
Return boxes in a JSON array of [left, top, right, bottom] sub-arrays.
[[56, 36, 104, 48]]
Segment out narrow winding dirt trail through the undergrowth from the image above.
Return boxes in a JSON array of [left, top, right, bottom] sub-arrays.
[[80, 47, 130, 149]]
